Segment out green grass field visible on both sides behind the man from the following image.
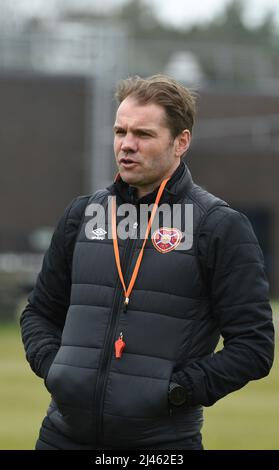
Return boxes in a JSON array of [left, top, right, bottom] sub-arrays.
[[0, 303, 279, 450]]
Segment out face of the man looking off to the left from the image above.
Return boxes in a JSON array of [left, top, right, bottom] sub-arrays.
[[114, 97, 180, 197]]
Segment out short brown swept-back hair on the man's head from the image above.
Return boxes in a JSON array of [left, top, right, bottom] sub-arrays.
[[115, 75, 196, 138]]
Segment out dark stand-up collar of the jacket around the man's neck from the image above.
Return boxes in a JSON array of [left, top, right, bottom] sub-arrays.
[[107, 162, 193, 205]]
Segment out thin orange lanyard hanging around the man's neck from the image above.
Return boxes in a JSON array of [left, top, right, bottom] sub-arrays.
[[111, 178, 169, 310]]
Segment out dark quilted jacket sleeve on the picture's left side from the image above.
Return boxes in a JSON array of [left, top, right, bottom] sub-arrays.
[[20, 196, 88, 378]]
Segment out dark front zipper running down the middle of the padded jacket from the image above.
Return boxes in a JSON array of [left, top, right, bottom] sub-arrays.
[[95, 239, 136, 448]]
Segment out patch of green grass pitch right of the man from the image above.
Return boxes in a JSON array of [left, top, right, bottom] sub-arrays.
[[203, 302, 279, 450]]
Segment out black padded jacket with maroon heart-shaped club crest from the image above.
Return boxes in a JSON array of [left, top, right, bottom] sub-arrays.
[[21, 163, 274, 448]]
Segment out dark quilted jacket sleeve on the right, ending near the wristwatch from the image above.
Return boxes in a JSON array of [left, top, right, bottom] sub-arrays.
[[173, 207, 274, 406]]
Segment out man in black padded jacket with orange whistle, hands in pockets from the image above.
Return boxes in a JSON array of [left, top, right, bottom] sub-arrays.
[[21, 75, 273, 449]]
